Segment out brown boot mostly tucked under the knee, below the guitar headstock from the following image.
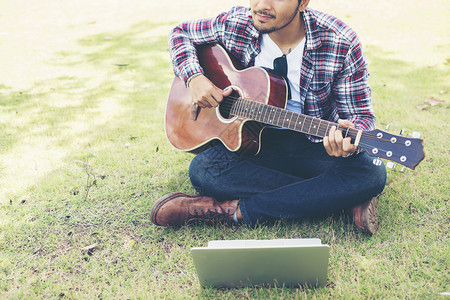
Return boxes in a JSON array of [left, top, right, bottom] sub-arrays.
[[353, 198, 378, 235]]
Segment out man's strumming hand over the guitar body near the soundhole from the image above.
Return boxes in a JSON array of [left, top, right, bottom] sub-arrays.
[[189, 74, 232, 108]]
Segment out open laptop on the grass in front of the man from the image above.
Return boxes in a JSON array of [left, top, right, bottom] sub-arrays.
[[191, 239, 330, 288]]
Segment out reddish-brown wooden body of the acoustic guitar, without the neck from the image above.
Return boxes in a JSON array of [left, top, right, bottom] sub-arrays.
[[165, 45, 287, 154]]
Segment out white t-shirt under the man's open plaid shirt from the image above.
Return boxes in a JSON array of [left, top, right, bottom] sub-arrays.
[[255, 34, 305, 112]]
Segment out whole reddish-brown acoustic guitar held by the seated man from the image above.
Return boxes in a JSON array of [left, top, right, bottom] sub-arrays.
[[165, 45, 425, 169]]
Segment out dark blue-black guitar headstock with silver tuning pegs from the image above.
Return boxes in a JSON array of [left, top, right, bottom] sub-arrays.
[[359, 129, 425, 169]]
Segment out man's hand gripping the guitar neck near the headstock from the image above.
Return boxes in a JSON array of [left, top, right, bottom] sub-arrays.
[[323, 119, 356, 157]]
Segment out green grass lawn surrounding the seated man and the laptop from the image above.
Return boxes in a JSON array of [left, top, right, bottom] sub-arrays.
[[0, 6, 450, 299]]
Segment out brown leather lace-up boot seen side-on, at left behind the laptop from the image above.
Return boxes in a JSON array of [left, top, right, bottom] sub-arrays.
[[151, 193, 239, 227]]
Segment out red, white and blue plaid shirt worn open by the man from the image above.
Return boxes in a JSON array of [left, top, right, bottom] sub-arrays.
[[169, 6, 375, 143]]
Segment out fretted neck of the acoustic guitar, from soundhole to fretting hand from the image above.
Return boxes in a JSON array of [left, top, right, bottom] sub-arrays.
[[230, 98, 358, 142]]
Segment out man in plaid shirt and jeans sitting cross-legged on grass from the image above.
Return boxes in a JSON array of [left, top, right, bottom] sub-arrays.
[[151, 0, 386, 234]]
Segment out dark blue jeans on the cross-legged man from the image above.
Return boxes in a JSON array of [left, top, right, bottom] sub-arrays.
[[189, 128, 386, 226]]
